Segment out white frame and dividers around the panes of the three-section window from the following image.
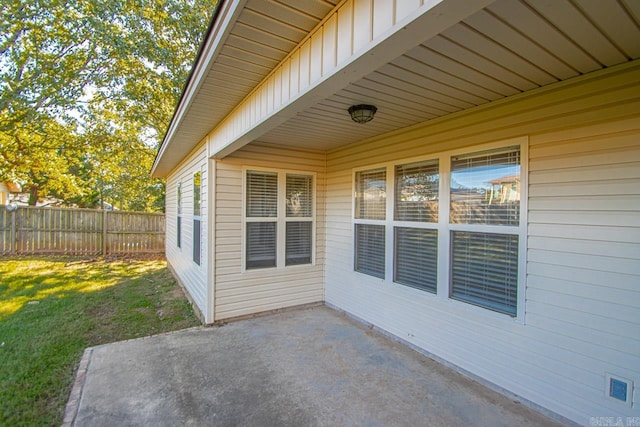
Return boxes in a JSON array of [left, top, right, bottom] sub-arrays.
[[351, 136, 529, 324]]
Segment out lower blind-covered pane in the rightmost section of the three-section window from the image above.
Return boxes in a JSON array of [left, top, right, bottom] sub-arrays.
[[451, 231, 518, 317]]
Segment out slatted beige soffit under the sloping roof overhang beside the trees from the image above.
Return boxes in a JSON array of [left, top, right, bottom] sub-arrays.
[[153, 0, 339, 176]]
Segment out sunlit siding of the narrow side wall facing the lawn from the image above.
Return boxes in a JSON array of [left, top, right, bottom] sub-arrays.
[[165, 147, 209, 314]]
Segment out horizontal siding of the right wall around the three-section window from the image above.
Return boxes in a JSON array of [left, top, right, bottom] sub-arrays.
[[325, 61, 640, 424]]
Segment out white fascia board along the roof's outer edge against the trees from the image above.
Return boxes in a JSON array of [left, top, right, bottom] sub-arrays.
[[151, 0, 247, 177]]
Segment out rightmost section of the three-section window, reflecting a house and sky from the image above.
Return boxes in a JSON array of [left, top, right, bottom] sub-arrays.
[[450, 147, 521, 316]]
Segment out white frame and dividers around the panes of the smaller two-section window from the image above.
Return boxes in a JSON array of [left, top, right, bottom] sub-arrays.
[[241, 166, 317, 274]]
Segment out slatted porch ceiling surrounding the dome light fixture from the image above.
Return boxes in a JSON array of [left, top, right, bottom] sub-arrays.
[[255, 0, 640, 150]]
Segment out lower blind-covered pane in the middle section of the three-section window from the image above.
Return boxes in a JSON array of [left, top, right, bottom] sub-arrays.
[[393, 227, 438, 293]]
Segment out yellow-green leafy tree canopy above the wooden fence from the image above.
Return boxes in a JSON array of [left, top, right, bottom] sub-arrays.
[[0, 0, 215, 210]]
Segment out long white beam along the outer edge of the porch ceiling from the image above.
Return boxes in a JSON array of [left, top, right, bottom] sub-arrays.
[[207, 0, 495, 159]]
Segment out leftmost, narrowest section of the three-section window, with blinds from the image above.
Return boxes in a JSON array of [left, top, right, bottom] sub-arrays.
[[354, 168, 387, 279]]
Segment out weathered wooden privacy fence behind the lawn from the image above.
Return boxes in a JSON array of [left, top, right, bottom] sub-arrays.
[[0, 206, 165, 255]]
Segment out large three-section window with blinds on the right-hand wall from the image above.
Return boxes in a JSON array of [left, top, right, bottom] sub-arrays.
[[353, 140, 526, 317]]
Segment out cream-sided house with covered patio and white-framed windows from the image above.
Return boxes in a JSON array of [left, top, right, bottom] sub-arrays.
[[153, 0, 640, 425]]
